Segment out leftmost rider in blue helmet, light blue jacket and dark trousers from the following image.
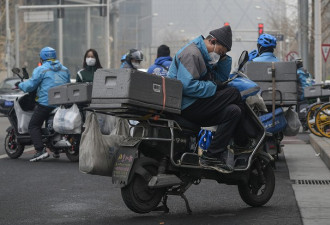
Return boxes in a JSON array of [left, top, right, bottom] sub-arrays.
[[17, 47, 70, 162]]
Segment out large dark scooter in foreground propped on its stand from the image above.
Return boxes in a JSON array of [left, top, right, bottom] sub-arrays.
[[89, 51, 275, 213]]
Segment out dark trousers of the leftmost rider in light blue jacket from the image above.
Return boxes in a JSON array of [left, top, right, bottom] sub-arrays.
[[29, 104, 54, 151]]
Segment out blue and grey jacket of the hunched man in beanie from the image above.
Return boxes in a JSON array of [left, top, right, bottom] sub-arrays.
[[168, 36, 231, 110]]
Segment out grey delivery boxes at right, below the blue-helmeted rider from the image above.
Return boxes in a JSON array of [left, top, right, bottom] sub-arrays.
[[245, 62, 298, 105]]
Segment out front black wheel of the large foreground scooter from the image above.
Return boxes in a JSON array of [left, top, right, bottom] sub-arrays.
[[238, 163, 275, 207]]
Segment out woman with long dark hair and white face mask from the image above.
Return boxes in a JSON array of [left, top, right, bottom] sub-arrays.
[[76, 49, 102, 82]]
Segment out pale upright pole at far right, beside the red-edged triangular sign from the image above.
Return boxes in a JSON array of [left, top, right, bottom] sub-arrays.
[[314, 0, 322, 83]]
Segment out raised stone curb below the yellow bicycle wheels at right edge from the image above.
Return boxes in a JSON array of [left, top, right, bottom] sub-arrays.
[[309, 134, 330, 169]]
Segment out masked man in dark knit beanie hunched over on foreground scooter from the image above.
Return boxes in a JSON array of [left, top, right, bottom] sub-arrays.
[[169, 26, 245, 171]]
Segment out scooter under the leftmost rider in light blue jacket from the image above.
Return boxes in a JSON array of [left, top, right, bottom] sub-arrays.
[[5, 68, 81, 162]]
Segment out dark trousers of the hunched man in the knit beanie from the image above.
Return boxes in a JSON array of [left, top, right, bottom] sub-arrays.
[[181, 87, 245, 154]]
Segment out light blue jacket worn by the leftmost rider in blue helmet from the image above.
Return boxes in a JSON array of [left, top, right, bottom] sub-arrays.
[[18, 60, 70, 106]]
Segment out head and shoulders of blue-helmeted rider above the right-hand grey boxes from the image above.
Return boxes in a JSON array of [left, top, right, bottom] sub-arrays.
[[252, 34, 279, 62]]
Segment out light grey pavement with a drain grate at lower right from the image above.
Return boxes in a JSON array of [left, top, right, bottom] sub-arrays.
[[283, 135, 330, 225]]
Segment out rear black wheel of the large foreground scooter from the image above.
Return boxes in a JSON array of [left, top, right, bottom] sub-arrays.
[[121, 165, 165, 213]]
